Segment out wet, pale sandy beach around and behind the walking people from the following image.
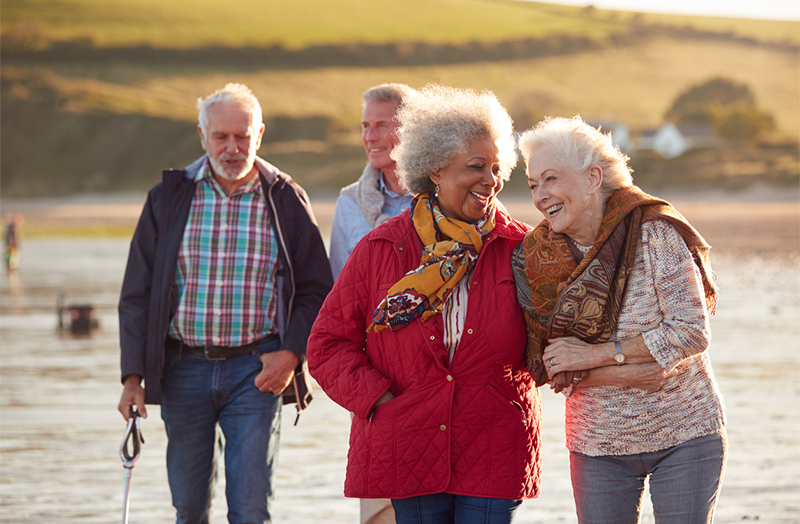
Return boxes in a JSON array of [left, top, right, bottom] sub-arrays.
[[0, 188, 800, 524]]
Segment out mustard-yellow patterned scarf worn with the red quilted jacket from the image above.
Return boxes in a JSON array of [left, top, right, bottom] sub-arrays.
[[367, 194, 495, 333]]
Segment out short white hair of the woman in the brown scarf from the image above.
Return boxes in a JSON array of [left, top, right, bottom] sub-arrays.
[[519, 116, 633, 195]]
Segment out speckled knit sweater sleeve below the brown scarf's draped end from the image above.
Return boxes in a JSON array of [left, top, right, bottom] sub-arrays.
[[639, 221, 711, 371]]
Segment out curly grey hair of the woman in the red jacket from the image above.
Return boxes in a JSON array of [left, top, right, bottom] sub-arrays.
[[391, 84, 517, 195]]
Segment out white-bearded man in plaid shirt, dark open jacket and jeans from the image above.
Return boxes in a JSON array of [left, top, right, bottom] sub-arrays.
[[119, 84, 333, 523]]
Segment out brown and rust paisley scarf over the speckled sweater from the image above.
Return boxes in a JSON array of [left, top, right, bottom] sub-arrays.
[[513, 186, 717, 385]]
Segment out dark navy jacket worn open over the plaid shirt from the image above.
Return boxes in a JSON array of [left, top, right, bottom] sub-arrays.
[[119, 156, 333, 411]]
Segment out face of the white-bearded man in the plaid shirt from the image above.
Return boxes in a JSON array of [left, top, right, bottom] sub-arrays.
[[198, 103, 264, 181]]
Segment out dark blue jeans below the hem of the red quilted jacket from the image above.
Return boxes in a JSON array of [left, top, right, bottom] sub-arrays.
[[392, 493, 522, 524]]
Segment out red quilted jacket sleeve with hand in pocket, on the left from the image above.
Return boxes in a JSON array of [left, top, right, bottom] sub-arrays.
[[308, 235, 391, 418]]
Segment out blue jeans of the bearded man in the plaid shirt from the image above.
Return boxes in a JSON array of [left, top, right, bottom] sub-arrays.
[[161, 341, 282, 524]]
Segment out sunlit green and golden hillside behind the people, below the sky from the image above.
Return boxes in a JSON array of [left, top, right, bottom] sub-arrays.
[[0, 0, 800, 197]]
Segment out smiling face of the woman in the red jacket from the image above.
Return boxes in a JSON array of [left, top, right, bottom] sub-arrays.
[[430, 138, 503, 222]]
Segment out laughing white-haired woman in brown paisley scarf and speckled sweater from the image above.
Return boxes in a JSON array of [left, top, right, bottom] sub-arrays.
[[514, 117, 727, 524]]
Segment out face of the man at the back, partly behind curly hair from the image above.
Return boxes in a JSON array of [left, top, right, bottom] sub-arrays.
[[361, 102, 400, 174]]
